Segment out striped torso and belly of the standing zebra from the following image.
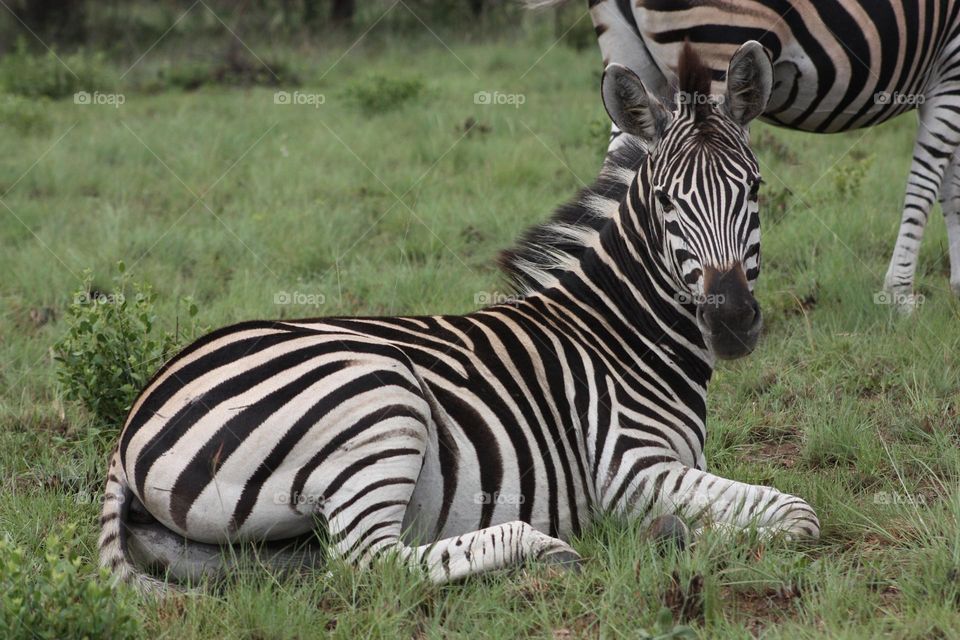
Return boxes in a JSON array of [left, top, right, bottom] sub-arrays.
[[621, 0, 940, 133]]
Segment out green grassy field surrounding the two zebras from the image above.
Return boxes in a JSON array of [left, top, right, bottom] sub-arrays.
[[0, 23, 960, 638]]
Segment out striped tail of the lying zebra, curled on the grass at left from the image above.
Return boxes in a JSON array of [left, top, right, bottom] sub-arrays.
[[100, 451, 167, 594]]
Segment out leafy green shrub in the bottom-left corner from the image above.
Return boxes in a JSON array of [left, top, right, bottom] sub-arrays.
[[0, 525, 141, 640]]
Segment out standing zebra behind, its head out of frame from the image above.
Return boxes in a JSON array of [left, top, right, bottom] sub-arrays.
[[528, 0, 960, 312]]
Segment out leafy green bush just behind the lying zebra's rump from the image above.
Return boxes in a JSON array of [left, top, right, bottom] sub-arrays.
[[55, 263, 206, 427]]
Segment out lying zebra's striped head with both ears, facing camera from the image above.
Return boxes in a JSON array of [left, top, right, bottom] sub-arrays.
[[602, 40, 773, 358]]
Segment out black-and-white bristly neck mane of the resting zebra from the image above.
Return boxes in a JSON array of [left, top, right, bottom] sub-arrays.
[[498, 135, 647, 295]]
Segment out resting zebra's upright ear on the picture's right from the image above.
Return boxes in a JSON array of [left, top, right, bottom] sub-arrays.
[[723, 40, 773, 127]]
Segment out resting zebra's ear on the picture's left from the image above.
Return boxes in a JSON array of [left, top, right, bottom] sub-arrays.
[[601, 64, 670, 142]]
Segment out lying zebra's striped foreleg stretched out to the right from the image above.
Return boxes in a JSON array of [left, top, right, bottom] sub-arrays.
[[619, 462, 820, 539]]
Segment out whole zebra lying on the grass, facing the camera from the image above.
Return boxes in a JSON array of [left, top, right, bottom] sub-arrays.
[[99, 42, 820, 589]]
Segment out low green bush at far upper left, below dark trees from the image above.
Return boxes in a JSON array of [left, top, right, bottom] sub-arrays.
[[0, 39, 112, 98]]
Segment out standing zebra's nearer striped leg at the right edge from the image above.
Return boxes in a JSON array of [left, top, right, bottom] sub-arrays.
[[884, 94, 960, 313]]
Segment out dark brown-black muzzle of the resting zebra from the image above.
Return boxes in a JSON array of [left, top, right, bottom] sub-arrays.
[[697, 263, 763, 360]]
